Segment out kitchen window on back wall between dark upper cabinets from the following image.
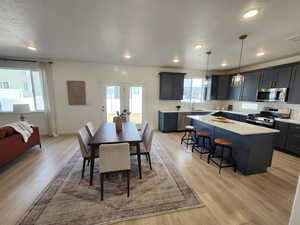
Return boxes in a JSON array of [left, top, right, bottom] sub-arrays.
[[182, 78, 206, 103]]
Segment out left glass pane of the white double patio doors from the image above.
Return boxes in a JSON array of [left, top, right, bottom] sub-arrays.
[[106, 86, 120, 122]]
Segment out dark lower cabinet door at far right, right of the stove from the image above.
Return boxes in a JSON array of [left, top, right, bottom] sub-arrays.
[[286, 124, 300, 155]]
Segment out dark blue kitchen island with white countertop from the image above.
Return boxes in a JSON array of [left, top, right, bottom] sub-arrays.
[[188, 115, 279, 175]]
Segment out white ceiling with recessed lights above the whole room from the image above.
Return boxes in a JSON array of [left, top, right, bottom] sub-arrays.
[[0, 0, 300, 69]]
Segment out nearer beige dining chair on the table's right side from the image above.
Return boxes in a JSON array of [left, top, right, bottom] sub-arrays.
[[130, 125, 154, 170]]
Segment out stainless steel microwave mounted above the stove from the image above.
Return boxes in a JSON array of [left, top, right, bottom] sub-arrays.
[[256, 88, 288, 102]]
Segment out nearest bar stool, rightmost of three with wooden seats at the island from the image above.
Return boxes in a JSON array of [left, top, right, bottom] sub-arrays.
[[208, 138, 236, 174]]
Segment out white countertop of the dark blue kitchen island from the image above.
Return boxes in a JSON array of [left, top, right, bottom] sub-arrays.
[[188, 115, 279, 135]]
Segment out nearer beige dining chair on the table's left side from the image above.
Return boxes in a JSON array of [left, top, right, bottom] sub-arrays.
[[77, 127, 99, 178]]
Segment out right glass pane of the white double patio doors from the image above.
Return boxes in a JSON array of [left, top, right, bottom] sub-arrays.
[[129, 87, 143, 124]]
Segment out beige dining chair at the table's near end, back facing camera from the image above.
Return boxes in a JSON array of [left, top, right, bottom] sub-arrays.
[[99, 143, 130, 201]]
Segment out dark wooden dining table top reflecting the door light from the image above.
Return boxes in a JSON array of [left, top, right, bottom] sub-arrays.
[[89, 122, 142, 145]]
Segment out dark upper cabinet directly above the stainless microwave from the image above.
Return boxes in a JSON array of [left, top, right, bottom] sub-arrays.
[[260, 65, 292, 88]]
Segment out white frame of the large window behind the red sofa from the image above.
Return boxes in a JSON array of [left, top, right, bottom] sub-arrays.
[[0, 66, 46, 114]]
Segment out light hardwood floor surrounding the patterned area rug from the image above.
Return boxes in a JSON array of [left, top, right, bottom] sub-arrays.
[[0, 132, 300, 225]]
